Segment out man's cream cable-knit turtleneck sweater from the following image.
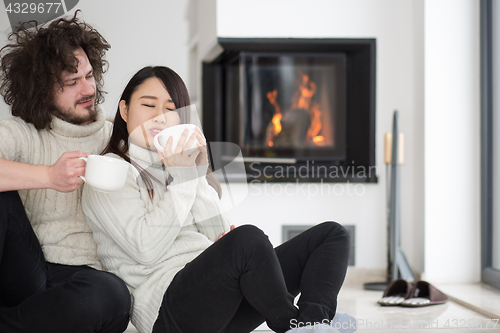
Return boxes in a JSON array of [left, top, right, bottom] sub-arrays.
[[0, 107, 112, 268]]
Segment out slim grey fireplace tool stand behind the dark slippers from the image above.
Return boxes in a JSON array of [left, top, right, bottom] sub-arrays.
[[364, 110, 415, 290]]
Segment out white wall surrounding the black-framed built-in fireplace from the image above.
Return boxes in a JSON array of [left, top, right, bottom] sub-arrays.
[[207, 0, 423, 271]]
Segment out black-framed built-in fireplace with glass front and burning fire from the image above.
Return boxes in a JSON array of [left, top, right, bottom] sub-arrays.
[[203, 38, 377, 182]]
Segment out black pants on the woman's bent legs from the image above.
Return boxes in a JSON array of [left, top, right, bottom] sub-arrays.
[[153, 222, 350, 333]]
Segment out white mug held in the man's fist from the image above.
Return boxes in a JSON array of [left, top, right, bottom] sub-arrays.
[[80, 155, 130, 192]]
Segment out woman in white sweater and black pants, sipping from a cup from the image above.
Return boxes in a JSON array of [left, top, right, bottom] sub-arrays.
[[83, 67, 349, 333]]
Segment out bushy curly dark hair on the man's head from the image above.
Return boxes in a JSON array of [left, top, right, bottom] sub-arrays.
[[0, 11, 110, 129]]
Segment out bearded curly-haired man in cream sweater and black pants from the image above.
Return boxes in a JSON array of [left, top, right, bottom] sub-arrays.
[[0, 14, 130, 333]]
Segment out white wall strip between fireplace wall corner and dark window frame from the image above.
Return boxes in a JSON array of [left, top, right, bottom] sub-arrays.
[[424, 0, 481, 283]]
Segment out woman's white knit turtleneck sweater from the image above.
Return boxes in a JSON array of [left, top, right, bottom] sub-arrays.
[[82, 145, 229, 333]]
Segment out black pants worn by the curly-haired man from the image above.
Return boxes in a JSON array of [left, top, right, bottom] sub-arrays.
[[0, 192, 130, 333]]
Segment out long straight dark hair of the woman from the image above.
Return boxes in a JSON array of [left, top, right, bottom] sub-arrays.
[[102, 66, 222, 199]]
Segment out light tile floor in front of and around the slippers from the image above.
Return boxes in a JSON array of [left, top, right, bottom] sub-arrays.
[[127, 285, 500, 333]]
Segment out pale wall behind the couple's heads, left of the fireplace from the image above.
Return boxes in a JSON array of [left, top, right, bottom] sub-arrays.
[[0, 0, 188, 119]]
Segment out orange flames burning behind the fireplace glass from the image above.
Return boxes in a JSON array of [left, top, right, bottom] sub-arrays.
[[267, 71, 325, 147]]
